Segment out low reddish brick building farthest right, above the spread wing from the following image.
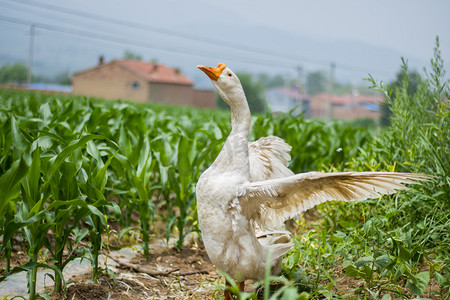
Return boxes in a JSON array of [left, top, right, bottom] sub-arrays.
[[310, 93, 384, 120]]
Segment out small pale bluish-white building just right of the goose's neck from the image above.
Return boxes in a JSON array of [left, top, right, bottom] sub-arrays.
[[266, 87, 310, 116]]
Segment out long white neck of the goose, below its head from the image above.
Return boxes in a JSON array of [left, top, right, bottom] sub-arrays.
[[213, 93, 251, 178]]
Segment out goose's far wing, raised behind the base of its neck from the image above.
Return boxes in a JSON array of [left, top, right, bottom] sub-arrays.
[[248, 136, 294, 182]]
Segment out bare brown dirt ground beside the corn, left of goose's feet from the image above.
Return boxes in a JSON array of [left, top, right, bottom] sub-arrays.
[[51, 246, 223, 300]]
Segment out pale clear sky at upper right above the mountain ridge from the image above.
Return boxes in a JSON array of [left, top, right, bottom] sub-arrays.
[[209, 0, 450, 62]]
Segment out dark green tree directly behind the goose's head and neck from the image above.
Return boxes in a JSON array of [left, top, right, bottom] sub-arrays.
[[217, 73, 266, 112]]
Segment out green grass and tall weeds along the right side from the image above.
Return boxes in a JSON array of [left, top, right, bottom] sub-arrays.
[[278, 37, 450, 299]]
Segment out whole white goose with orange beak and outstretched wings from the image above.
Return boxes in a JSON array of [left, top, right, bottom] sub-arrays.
[[196, 63, 428, 299]]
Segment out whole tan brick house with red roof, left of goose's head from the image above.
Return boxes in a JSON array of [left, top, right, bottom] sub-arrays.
[[72, 59, 216, 108]]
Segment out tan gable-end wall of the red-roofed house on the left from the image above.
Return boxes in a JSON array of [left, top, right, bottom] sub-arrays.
[[72, 64, 149, 102]]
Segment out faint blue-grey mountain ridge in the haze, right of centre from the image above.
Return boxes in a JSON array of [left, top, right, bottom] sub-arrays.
[[173, 23, 433, 82]]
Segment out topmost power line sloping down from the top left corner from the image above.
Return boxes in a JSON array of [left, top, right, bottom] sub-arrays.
[[0, 0, 391, 75]]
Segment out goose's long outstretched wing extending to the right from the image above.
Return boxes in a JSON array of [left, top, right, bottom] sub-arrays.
[[239, 172, 431, 229]]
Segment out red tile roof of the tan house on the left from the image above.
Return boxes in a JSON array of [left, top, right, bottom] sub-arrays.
[[116, 60, 194, 85]]
